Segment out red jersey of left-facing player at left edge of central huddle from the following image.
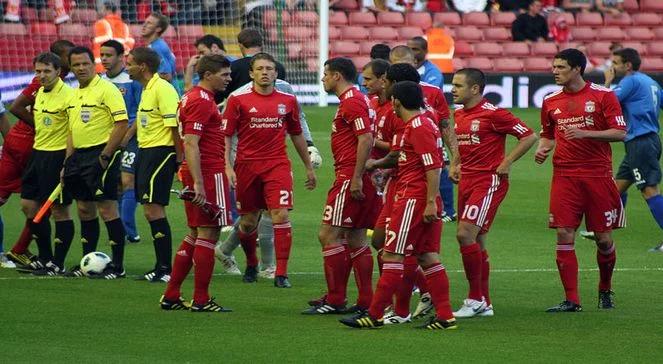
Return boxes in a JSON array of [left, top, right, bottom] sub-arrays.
[[331, 87, 375, 178]]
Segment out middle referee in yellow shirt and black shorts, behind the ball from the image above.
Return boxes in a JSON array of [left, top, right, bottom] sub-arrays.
[[63, 47, 128, 279]]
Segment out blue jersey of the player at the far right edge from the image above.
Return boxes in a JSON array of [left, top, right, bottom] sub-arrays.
[[615, 72, 661, 141]]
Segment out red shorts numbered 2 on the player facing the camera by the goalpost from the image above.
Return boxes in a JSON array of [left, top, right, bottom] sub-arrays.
[[235, 159, 293, 214]]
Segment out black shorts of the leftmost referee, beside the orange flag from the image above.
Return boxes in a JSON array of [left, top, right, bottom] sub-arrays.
[[21, 149, 71, 205]]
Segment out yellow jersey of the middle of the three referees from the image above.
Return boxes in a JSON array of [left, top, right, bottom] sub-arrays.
[[69, 75, 128, 148]]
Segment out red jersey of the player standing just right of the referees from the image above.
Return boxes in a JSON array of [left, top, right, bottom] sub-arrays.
[[179, 86, 226, 173]]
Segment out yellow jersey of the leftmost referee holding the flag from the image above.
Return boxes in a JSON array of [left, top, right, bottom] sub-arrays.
[[32, 77, 74, 151]]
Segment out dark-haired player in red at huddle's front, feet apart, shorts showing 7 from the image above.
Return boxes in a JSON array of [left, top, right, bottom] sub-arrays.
[[340, 81, 457, 330]]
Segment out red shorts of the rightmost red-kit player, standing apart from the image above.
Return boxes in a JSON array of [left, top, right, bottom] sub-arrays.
[[548, 176, 626, 233]]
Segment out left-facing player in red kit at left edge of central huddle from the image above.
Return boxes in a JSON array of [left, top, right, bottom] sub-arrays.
[[302, 57, 380, 315]]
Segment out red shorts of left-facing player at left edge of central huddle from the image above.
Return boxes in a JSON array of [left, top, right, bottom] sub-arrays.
[[322, 173, 382, 229]]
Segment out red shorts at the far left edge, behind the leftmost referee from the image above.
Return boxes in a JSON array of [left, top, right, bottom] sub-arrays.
[[0, 128, 34, 200]]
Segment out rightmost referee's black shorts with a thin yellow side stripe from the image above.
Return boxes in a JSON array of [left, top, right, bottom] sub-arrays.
[[135, 146, 177, 206]]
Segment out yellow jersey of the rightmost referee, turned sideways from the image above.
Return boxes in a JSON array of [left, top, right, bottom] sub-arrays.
[[136, 73, 179, 148]]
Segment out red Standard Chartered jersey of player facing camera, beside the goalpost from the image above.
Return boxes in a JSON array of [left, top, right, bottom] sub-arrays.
[[223, 88, 302, 161]]
